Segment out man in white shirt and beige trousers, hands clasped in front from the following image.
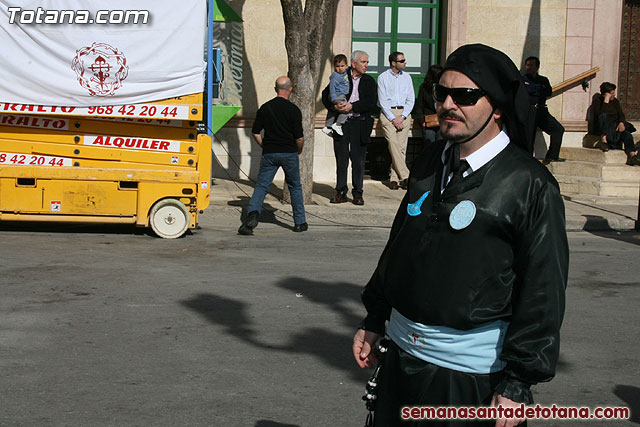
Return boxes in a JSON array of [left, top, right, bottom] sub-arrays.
[[378, 52, 416, 190]]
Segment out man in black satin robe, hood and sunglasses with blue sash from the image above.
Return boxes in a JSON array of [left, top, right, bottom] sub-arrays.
[[353, 45, 569, 427]]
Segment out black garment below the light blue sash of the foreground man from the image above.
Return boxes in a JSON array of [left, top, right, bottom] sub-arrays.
[[374, 342, 526, 427]]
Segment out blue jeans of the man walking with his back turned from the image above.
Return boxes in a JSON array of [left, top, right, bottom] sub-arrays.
[[247, 153, 307, 224]]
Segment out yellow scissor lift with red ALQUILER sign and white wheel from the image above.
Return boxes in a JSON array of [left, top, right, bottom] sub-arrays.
[[0, 93, 211, 238]]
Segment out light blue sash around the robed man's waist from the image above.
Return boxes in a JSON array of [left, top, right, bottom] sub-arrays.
[[387, 309, 509, 374]]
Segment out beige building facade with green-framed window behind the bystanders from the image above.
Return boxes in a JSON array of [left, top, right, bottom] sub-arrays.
[[214, 0, 640, 182]]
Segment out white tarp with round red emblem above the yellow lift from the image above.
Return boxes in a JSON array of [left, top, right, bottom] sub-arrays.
[[0, 0, 207, 107]]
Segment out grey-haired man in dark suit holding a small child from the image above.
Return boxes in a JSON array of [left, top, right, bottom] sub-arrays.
[[322, 50, 378, 206]]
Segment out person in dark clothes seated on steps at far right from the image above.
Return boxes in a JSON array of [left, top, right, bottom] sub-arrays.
[[592, 82, 640, 166]]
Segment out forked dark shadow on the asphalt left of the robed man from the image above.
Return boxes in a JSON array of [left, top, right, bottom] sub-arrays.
[[181, 277, 368, 381]]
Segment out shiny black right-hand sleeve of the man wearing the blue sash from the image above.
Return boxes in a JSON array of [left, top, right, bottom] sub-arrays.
[[495, 183, 569, 404]]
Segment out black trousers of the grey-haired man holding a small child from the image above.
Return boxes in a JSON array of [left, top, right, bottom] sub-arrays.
[[333, 120, 368, 196]]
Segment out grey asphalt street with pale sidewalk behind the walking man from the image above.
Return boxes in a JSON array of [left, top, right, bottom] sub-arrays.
[[0, 182, 640, 427]]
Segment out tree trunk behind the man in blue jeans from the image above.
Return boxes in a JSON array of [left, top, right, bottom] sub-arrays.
[[280, 0, 337, 204]]
